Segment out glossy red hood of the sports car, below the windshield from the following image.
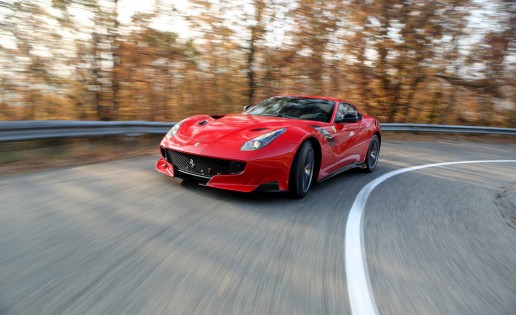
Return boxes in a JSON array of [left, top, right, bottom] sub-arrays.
[[176, 114, 319, 145]]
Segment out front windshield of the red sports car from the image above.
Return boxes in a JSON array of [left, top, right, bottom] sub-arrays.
[[245, 97, 335, 122]]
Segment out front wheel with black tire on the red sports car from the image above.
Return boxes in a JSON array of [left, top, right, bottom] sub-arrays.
[[289, 141, 315, 199]]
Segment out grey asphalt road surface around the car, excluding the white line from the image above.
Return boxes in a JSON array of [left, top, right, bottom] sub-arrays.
[[0, 142, 516, 315]]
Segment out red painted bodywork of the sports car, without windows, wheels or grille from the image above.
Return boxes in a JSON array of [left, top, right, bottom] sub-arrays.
[[156, 96, 381, 196]]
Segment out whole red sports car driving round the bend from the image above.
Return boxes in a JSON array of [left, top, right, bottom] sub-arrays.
[[156, 96, 381, 198]]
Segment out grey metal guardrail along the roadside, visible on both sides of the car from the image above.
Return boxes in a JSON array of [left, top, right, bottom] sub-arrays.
[[0, 120, 516, 142]]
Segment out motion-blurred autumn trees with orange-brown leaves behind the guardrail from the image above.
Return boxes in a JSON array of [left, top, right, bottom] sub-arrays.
[[0, 0, 516, 127]]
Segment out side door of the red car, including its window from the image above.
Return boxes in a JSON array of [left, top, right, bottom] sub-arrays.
[[333, 103, 365, 170]]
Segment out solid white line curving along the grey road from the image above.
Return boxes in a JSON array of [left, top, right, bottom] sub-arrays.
[[344, 160, 516, 315]]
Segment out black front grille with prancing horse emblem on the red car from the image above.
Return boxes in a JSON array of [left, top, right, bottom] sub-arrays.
[[161, 148, 245, 178]]
